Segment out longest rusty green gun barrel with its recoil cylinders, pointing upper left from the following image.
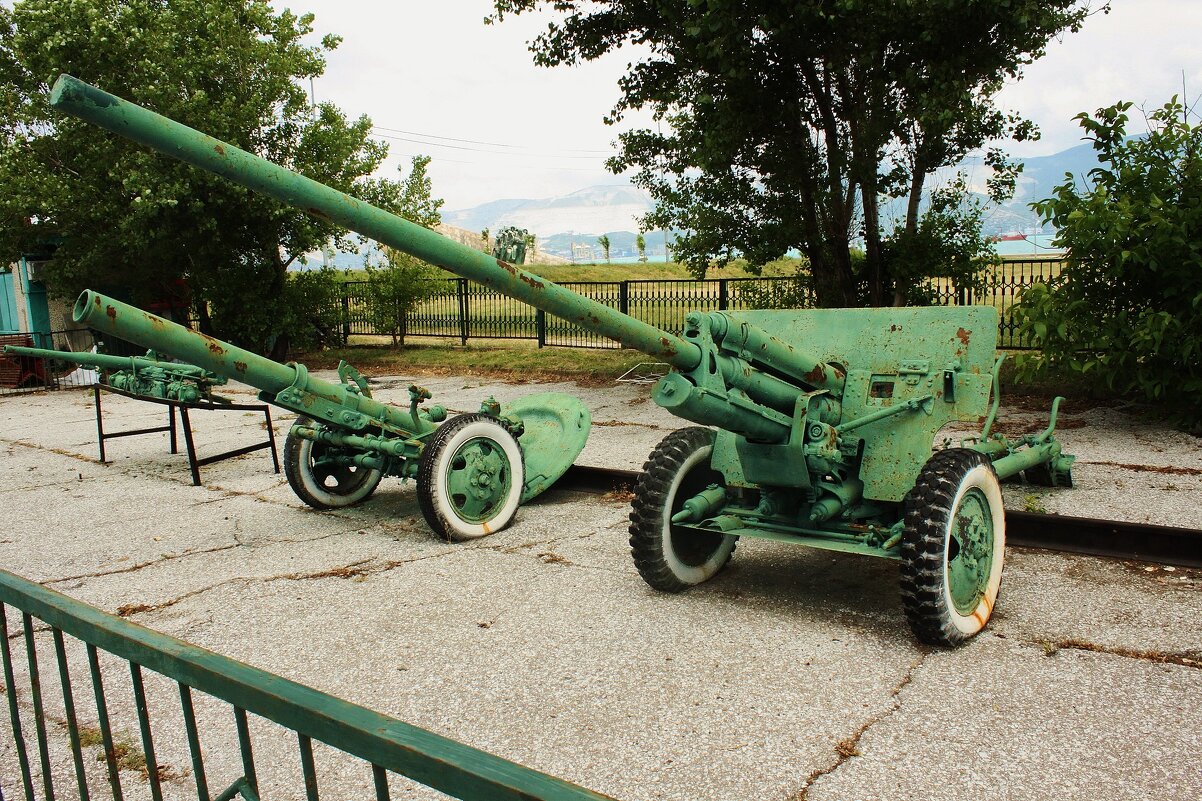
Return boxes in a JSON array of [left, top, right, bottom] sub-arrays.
[[50, 75, 844, 440]]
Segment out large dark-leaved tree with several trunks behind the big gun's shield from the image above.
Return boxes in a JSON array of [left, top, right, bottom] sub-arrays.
[[488, 0, 1107, 305]]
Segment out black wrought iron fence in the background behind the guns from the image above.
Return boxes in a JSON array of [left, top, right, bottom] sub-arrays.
[[343, 259, 1060, 349]]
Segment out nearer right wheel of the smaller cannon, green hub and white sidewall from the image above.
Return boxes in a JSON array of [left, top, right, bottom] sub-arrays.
[[417, 414, 525, 540]]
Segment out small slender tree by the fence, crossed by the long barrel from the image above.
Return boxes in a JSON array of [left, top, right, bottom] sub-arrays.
[[367, 155, 446, 346]]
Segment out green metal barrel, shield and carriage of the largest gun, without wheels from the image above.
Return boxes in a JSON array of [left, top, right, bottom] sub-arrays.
[[52, 76, 1071, 583]]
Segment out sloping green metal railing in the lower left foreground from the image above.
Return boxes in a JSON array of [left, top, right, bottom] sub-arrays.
[[0, 570, 607, 801]]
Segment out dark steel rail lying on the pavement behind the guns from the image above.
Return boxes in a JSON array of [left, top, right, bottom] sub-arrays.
[[557, 465, 1202, 569]]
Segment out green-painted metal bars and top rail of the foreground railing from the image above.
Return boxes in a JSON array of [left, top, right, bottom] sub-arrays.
[[0, 570, 608, 801]]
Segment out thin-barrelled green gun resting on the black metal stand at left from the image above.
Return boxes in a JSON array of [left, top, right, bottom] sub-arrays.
[[4, 345, 227, 403]]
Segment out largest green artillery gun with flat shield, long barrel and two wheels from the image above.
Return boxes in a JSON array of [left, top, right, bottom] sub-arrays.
[[50, 76, 1072, 645]]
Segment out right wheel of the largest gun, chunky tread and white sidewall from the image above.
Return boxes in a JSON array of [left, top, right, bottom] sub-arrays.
[[902, 447, 1006, 646]]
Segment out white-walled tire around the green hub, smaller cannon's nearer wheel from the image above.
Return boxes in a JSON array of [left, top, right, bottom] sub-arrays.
[[417, 414, 525, 541]]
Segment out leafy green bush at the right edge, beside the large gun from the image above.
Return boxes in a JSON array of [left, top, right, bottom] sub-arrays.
[[1018, 99, 1202, 428]]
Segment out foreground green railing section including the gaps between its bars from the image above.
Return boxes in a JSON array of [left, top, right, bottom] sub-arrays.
[[0, 570, 607, 801]]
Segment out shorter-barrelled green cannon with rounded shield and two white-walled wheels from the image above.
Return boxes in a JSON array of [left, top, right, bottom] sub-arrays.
[[73, 290, 591, 540]]
